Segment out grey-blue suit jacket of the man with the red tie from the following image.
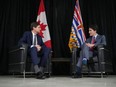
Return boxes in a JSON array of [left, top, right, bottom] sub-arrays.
[[86, 35, 106, 47]]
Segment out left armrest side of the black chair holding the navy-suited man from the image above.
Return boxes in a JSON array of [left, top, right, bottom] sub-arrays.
[[8, 45, 27, 73]]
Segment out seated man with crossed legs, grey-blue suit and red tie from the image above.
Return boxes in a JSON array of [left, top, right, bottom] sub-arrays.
[[76, 25, 106, 78]]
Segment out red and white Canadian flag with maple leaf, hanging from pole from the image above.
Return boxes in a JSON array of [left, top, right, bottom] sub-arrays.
[[37, 0, 51, 48]]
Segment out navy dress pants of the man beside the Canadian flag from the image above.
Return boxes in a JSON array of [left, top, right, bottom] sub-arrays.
[[30, 47, 50, 73]]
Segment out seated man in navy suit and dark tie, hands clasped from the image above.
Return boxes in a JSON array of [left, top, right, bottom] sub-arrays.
[[18, 22, 49, 79]]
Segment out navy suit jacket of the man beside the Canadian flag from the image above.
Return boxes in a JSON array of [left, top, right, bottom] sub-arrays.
[[18, 31, 45, 48]]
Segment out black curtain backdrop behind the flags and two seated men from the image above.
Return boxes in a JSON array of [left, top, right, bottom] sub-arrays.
[[0, 0, 116, 74]]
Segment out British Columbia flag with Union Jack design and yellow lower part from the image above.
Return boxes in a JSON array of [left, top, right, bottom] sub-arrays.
[[68, 0, 86, 50]]
